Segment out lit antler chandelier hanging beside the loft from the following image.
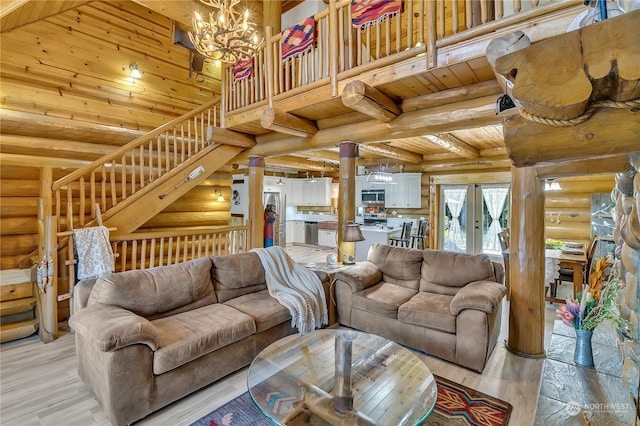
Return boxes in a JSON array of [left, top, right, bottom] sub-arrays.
[[189, 0, 264, 64]]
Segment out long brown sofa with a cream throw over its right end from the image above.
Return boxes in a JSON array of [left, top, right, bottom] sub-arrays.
[[69, 253, 329, 425]]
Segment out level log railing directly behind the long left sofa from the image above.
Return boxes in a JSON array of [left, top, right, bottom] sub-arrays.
[[110, 225, 247, 272]]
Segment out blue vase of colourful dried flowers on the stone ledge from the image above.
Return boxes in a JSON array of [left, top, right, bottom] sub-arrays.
[[556, 256, 628, 367]]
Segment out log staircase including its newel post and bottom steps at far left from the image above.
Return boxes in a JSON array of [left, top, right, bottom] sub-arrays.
[[27, 98, 249, 342]]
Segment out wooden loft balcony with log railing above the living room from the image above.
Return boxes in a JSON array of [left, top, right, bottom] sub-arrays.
[[222, 0, 584, 146]]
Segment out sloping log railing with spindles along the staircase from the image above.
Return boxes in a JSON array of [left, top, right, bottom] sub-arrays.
[[51, 98, 220, 232]]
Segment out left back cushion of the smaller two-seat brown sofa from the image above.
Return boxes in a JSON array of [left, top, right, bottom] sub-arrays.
[[367, 244, 422, 290]]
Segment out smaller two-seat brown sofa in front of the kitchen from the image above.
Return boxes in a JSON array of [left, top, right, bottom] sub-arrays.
[[335, 244, 506, 371]]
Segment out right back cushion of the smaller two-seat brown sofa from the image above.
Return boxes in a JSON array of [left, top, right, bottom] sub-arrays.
[[420, 250, 496, 296]]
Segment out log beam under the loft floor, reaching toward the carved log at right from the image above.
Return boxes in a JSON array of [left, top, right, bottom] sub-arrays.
[[401, 80, 502, 112]]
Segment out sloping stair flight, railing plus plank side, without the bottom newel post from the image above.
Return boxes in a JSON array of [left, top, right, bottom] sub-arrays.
[[50, 99, 244, 234]]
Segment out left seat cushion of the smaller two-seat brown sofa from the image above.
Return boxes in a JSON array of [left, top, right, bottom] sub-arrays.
[[351, 281, 417, 318]]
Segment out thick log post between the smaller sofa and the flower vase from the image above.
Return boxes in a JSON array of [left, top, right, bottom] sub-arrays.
[[507, 167, 545, 358]]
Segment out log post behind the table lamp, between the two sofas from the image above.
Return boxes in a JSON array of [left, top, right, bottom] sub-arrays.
[[338, 142, 358, 261]]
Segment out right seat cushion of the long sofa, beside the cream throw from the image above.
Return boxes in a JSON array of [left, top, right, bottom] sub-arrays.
[[224, 290, 291, 333]]
